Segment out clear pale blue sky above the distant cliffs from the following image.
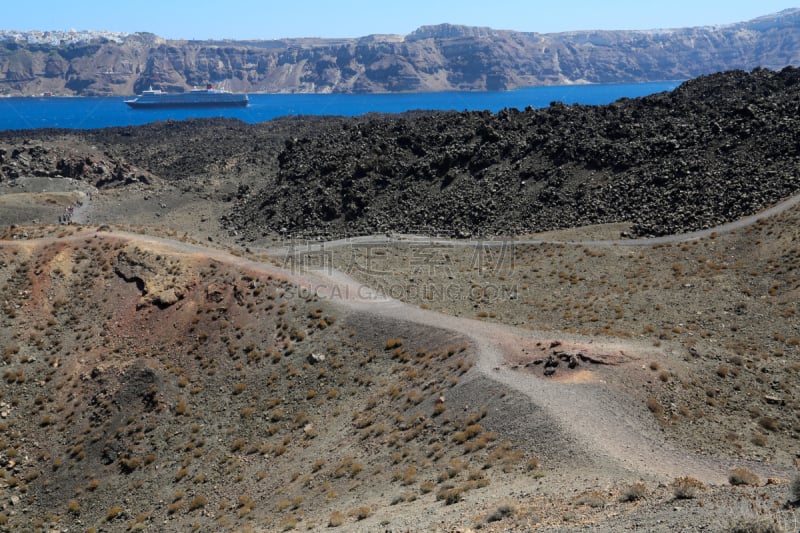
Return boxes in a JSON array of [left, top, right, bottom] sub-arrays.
[[0, 0, 800, 39]]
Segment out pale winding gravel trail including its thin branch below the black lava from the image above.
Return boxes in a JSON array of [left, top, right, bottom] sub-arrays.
[[6, 191, 800, 483]]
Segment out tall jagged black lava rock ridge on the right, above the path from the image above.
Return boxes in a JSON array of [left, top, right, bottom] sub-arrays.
[[226, 68, 800, 238]]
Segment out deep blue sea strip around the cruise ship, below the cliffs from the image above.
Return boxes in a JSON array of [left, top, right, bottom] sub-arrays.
[[0, 81, 680, 130]]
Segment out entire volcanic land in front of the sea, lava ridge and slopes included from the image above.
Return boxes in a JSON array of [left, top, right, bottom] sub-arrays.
[[0, 68, 800, 533]]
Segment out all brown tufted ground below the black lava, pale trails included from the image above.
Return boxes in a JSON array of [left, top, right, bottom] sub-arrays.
[[0, 92, 800, 531]]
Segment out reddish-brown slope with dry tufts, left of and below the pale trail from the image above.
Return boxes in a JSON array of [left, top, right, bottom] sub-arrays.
[[0, 230, 500, 531]]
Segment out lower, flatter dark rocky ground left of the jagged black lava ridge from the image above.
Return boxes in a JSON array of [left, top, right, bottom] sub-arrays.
[[0, 117, 338, 188]]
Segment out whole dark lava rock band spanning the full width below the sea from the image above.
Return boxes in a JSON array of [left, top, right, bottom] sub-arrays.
[[0, 68, 800, 240]]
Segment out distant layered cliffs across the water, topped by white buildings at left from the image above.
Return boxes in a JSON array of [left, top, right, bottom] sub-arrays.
[[0, 9, 800, 95]]
